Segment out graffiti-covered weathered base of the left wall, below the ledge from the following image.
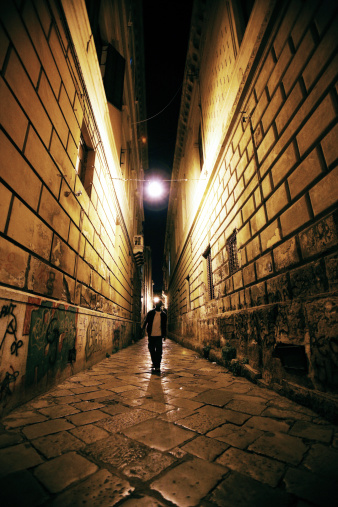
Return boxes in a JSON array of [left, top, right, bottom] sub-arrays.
[[0, 289, 133, 414]]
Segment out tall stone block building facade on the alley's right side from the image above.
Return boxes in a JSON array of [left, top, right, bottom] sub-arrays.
[[164, 0, 338, 414]]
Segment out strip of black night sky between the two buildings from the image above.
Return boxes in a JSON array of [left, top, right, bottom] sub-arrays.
[[143, 0, 192, 292]]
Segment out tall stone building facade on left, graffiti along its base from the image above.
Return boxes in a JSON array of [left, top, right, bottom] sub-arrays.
[[0, 0, 147, 416]]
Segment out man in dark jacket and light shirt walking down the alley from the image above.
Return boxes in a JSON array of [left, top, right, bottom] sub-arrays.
[[142, 300, 167, 372]]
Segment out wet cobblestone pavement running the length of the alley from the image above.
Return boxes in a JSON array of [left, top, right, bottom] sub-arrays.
[[0, 339, 338, 507]]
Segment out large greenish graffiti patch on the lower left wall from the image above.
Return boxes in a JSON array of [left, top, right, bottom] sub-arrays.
[[25, 301, 76, 386]]
